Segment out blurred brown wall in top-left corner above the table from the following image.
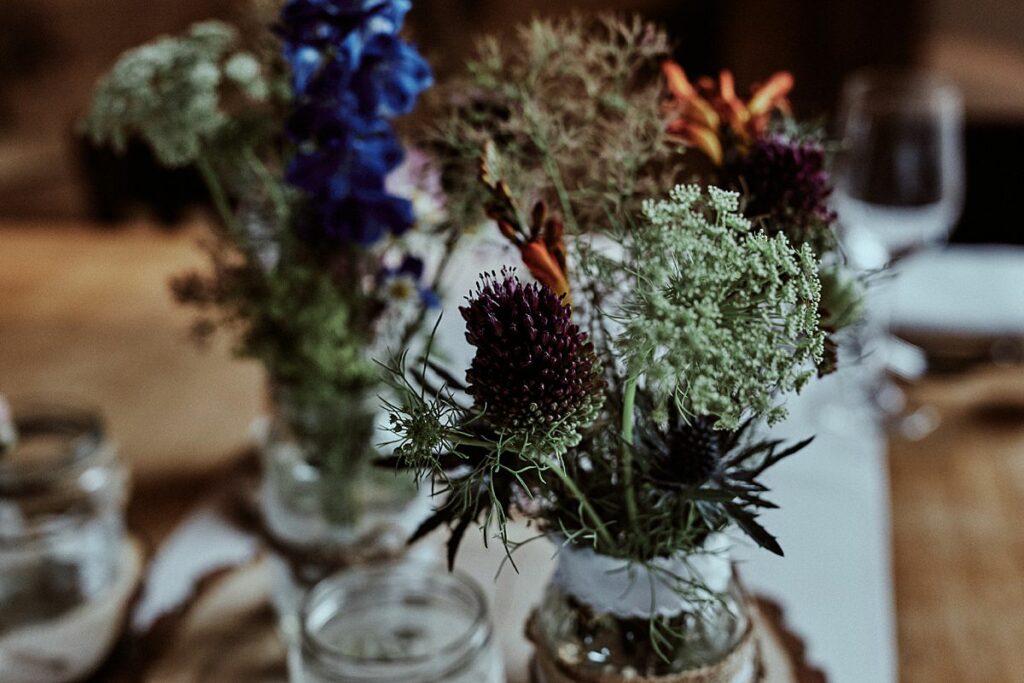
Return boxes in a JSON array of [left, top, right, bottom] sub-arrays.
[[0, 0, 233, 219]]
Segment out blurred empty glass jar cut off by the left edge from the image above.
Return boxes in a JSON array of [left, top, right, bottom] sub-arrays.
[[0, 405, 127, 634]]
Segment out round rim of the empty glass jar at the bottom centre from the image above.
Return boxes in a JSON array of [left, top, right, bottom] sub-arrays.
[[300, 558, 494, 683]]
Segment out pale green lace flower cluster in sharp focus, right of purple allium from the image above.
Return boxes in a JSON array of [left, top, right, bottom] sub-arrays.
[[620, 185, 824, 429]]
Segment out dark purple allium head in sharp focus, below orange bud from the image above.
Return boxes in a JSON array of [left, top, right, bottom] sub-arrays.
[[459, 270, 603, 444]]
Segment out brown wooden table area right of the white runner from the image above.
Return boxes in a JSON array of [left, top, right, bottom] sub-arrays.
[[889, 367, 1024, 683]]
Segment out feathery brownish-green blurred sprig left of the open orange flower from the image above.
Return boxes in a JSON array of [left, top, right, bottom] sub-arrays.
[[423, 14, 679, 232]]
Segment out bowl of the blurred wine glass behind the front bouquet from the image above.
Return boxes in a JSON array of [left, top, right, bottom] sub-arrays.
[[836, 70, 964, 268]]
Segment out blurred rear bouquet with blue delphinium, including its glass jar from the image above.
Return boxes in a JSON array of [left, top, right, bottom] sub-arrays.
[[83, 0, 458, 581]]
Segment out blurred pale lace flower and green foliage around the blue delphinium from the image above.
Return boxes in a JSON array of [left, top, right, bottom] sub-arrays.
[[81, 20, 440, 438]]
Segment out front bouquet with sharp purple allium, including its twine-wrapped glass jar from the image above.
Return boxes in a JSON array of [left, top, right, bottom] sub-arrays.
[[389, 15, 859, 683]]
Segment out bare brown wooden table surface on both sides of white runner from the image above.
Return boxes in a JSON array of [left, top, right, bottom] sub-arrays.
[[0, 224, 1024, 683]]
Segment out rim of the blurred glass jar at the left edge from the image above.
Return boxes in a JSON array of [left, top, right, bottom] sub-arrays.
[[0, 399, 108, 490]]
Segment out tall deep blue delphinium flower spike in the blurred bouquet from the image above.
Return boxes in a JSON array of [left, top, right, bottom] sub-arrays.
[[276, 0, 433, 245]]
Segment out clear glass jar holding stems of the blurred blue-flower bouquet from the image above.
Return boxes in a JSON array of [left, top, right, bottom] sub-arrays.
[[259, 386, 430, 639]]
